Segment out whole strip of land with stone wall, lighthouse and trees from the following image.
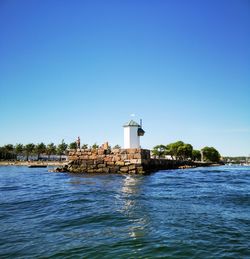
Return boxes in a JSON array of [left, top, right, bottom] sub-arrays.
[[0, 120, 223, 174]]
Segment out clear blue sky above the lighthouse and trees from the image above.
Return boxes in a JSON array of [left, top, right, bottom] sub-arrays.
[[0, 0, 250, 155]]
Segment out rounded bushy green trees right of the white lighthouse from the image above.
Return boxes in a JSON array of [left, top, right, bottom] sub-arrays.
[[152, 141, 221, 162]]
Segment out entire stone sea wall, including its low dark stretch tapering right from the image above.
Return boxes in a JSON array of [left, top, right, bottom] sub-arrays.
[[64, 148, 211, 174]]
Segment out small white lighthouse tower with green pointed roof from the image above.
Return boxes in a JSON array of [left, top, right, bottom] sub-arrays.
[[123, 120, 145, 148]]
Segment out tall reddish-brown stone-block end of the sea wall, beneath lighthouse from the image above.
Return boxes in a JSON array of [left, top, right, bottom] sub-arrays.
[[62, 148, 150, 174]]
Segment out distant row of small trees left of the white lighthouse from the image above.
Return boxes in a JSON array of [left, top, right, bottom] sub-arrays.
[[0, 140, 121, 161]]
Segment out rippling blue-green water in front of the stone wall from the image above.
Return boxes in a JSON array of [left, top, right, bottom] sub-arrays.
[[0, 167, 250, 259]]
